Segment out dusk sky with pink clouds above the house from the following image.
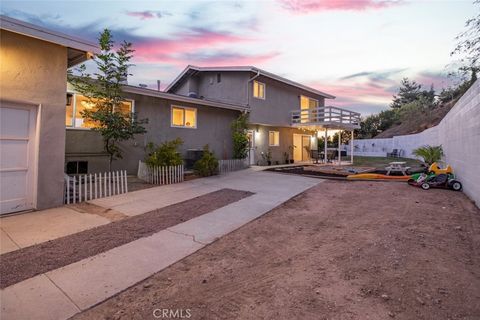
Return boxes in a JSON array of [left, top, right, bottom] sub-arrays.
[[0, 0, 480, 115]]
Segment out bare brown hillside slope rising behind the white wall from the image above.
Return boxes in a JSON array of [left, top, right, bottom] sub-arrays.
[[374, 100, 456, 138]]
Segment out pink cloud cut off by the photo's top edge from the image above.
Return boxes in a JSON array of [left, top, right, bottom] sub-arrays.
[[278, 0, 403, 13]]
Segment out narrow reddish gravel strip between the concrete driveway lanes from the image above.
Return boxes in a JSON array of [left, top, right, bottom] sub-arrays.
[[0, 189, 252, 289]]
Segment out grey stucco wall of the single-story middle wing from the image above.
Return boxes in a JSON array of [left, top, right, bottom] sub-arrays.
[[66, 94, 240, 174]]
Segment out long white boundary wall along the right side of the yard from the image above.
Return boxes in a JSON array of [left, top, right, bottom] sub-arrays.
[[347, 80, 480, 207]]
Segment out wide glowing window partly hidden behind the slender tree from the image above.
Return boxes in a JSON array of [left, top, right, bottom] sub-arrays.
[[65, 93, 134, 129]]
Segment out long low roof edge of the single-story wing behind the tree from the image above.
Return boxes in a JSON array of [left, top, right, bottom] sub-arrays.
[[123, 85, 248, 111]]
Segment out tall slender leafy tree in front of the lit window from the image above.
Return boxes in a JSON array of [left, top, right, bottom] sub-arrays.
[[68, 29, 147, 170]]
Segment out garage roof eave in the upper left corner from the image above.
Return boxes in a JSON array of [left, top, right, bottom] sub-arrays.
[[0, 15, 100, 67]]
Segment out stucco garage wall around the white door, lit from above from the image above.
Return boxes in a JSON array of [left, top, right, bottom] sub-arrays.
[[0, 30, 67, 209]]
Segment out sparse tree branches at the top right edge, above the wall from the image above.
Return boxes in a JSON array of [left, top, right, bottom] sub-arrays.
[[451, 0, 480, 79]]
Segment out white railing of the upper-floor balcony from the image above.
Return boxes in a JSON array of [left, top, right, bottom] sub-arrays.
[[291, 106, 360, 130]]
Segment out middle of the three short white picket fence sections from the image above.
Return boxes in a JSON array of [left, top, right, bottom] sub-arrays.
[[138, 161, 184, 184]]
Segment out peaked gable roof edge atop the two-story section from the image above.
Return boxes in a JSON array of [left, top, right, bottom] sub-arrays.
[[165, 65, 335, 99]]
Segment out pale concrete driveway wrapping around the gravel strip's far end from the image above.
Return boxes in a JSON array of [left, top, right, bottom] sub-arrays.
[[0, 169, 322, 319]]
